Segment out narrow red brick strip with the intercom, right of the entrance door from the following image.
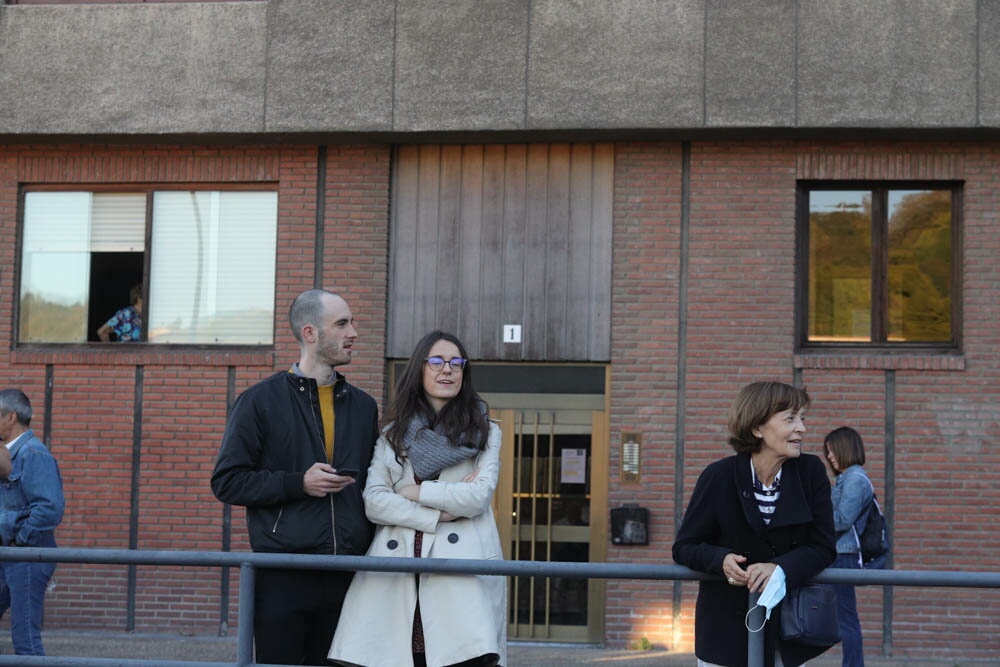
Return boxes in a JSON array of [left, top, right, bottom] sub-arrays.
[[605, 144, 681, 646]]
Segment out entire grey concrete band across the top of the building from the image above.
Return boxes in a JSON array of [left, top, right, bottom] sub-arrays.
[[0, 0, 1000, 140]]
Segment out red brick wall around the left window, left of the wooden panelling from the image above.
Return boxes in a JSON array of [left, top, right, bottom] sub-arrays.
[[0, 146, 389, 634]]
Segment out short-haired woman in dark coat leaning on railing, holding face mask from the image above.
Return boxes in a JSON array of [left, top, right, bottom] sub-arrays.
[[673, 382, 837, 667]]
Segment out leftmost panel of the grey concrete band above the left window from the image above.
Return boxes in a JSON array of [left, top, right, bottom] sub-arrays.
[[0, 3, 267, 134]]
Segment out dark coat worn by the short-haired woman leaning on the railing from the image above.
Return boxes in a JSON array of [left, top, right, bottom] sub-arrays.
[[673, 454, 837, 667]]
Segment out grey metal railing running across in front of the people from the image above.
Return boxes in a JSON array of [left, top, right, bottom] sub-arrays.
[[0, 547, 1000, 667]]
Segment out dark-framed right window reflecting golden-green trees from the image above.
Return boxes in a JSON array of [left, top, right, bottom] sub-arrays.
[[799, 182, 961, 349]]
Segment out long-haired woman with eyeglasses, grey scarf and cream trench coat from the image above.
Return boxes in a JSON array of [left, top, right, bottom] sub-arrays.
[[329, 331, 507, 667]]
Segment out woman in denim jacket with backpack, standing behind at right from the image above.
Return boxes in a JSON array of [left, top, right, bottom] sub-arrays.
[[823, 426, 875, 667]]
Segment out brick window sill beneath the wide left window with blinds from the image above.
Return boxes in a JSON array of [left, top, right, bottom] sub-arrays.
[[10, 343, 274, 366]]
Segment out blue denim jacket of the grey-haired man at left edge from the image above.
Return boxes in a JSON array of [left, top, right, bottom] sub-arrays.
[[14, 447, 66, 546]]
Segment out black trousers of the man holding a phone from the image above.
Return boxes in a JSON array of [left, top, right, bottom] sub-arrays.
[[253, 568, 354, 665]]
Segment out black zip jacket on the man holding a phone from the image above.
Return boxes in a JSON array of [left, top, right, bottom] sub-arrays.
[[212, 372, 378, 555]]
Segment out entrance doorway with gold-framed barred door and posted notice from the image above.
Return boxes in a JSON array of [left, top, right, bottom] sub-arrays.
[[476, 364, 609, 643]]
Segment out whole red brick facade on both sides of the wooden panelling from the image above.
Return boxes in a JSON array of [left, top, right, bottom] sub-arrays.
[[0, 141, 1000, 658]]
